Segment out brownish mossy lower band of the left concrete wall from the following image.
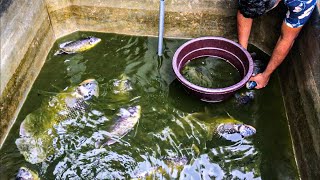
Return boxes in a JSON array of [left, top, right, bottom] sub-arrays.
[[0, 16, 55, 147]]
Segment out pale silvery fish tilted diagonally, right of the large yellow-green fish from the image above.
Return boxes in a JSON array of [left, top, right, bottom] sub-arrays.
[[96, 106, 141, 148]]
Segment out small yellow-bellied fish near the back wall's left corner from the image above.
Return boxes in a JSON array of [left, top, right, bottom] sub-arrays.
[[54, 36, 101, 55]]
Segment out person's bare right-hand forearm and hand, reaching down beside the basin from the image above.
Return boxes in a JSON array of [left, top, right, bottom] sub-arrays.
[[250, 22, 302, 89]]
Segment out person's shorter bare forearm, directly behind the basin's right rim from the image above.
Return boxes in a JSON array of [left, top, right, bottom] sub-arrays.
[[237, 11, 253, 49]]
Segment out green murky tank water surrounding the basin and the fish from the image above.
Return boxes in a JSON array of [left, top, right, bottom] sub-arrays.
[[0, 32, 298, 179]]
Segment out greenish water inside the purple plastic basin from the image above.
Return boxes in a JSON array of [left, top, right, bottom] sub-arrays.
[[181, 57, 241, 88]]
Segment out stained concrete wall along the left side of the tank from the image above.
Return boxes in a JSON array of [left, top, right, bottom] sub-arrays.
[[0, 0, 55, 147]]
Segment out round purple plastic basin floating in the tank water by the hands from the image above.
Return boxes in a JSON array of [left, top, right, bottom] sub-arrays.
[[172, 37, 253, 102]]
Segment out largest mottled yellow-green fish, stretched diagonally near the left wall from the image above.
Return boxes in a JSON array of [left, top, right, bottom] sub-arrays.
[[15, 79, 99, 164]]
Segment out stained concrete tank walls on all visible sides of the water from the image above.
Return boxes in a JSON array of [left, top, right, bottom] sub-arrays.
[[0, 0, 320, 179]]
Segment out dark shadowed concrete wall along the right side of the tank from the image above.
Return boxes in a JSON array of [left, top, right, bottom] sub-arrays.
[[279, 9, 320, 179]]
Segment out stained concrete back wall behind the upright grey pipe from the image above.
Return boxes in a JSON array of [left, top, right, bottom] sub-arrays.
[[46, 0, 236, 39]]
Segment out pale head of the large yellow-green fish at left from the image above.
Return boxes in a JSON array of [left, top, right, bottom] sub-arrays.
[[77, 79, 99, 100]]
